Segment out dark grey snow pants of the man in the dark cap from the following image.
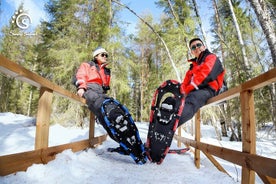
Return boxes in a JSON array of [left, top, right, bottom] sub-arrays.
[[178, 87, 216, 126]]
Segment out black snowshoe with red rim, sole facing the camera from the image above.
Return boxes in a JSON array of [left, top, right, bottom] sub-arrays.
[[146, 80, 184, 164]]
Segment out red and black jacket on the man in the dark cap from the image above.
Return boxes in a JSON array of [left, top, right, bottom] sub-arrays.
[[181, 49, 225, 95]]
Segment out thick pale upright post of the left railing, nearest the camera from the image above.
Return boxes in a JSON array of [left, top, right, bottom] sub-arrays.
[[35, 87, 53, 150]]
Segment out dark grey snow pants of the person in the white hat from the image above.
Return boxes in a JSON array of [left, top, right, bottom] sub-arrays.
[[83, 83, 118, 142]]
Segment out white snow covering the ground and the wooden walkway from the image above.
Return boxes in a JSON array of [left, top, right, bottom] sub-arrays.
[[0, 113, 276, 184]]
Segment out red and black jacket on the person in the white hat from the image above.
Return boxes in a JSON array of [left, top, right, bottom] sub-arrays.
[[76, 61, 110, 89]]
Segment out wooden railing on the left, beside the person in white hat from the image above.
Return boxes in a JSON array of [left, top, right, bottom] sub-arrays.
[[0, 55, 106, 176]]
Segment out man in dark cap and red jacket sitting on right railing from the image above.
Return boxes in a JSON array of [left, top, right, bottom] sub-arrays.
[[178, 38, 225, 126]]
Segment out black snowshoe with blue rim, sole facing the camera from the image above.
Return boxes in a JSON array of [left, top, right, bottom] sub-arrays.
[[101, 99, 147, 164]]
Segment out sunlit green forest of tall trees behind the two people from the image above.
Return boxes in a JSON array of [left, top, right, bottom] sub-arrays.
[[0, 0, 276, 139]]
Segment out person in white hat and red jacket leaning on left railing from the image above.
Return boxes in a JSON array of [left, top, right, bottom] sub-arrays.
[[75, 47, 116, 141]]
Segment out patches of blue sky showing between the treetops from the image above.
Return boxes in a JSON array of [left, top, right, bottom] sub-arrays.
[[0, 0, 214, 49]]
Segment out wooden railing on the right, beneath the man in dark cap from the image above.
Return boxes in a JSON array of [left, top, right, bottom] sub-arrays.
[[175, 68, 276, 184]]
